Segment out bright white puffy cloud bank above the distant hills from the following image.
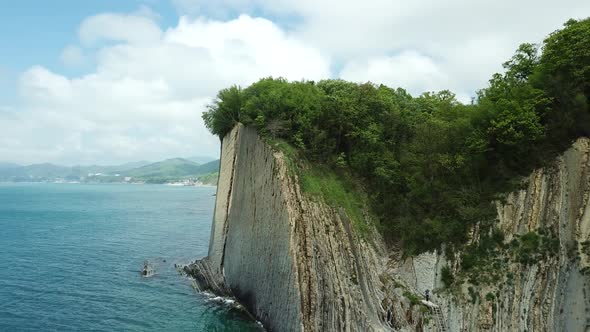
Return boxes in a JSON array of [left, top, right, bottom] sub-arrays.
[[0, 14, 330, 163]]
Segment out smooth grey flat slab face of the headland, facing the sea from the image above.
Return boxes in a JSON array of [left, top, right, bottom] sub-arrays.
[[193, 125, 301, 331]]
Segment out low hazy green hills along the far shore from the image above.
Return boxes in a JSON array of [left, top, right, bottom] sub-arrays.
[[0, 157, 219, 184]]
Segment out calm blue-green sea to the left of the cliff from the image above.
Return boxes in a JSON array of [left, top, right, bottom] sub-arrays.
[[0, 183, 259, 332]]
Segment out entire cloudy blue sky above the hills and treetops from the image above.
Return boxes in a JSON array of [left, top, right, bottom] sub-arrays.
[[0, 0, 590, 165]]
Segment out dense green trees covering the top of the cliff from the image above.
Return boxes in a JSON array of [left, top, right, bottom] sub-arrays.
[[203, 19, 590, 254]]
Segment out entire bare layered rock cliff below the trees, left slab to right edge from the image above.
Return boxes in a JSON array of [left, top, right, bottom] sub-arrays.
[[185, 125, 590, 331]]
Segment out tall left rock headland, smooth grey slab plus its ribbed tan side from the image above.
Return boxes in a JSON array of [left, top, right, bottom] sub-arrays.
[[186, 125, 398, 331]]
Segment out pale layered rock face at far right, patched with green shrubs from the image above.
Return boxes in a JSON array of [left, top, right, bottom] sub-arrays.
[[402, 138, 590, 331]]
